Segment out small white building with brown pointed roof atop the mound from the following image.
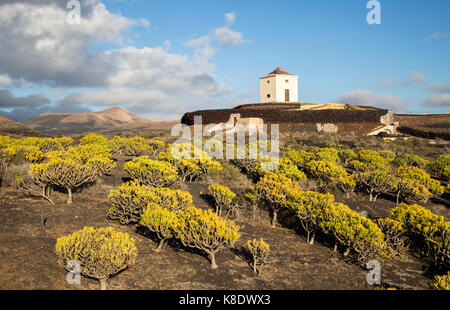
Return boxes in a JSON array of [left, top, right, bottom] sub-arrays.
[[259, 67, 298, 103]]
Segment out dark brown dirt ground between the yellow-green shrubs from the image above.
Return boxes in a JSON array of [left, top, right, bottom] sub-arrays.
[[0, 157, 448, 290]]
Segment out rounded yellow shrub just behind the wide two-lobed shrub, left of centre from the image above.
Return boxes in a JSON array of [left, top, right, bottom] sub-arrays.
[[124, 156, 178, 187]]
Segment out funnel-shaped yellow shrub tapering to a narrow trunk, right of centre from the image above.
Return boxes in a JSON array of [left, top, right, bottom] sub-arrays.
[[288, 191, 334, 244]]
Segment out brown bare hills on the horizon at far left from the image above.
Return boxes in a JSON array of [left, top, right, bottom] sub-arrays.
[[23, 108, 173, 135]]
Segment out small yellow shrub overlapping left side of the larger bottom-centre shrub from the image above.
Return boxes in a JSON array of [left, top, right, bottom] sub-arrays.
[[139, 204, 179, 252]]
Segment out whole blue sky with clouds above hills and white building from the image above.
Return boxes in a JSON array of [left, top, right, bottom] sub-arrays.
[[0, 0, 450, 121]]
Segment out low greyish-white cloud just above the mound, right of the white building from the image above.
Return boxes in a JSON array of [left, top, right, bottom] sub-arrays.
[[338, 89, 406, 112]]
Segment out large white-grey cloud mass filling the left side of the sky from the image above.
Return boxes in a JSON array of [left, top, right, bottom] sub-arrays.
[[0, 0, 243, 120]]
